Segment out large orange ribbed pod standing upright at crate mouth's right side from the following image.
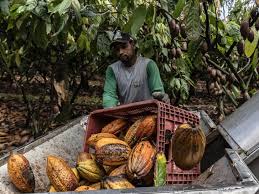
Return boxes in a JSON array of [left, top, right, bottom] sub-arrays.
[[126, 141, 156, 179]]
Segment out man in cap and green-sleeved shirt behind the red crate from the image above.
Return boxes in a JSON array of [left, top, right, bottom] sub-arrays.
[[103, 31, 170, 108]]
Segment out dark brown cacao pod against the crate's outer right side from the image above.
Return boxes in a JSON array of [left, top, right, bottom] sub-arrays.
[[172, 124, 206, 170]]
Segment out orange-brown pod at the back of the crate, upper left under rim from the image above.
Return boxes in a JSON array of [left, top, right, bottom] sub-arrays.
[[101, 119, 127, 134]]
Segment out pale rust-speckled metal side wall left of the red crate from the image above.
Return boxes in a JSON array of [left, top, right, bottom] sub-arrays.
[[0, 116, 88, 194]]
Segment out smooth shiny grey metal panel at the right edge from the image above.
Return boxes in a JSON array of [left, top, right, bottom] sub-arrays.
[[221, 93, 259, 153]]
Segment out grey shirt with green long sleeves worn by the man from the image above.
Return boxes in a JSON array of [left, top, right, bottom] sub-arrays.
[[103, 57, 164, 108]]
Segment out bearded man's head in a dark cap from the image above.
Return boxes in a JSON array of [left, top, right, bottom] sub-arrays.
[[111, 31, 136, 66]]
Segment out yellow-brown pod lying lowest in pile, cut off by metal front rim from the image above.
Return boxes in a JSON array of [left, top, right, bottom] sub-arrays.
[[103, 176, 135, 189]]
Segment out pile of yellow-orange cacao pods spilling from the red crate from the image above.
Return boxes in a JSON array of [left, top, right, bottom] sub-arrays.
[[8, 115, 169, 192]]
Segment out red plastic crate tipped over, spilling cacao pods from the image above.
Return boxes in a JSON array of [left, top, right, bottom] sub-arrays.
[[84, 100, 200, 185]]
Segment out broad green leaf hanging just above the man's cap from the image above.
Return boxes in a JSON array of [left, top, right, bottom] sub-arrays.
[[125, 5, 147, 37]]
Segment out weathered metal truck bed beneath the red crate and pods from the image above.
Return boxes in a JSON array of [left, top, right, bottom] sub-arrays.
[[0, 116, 259, 194]]
